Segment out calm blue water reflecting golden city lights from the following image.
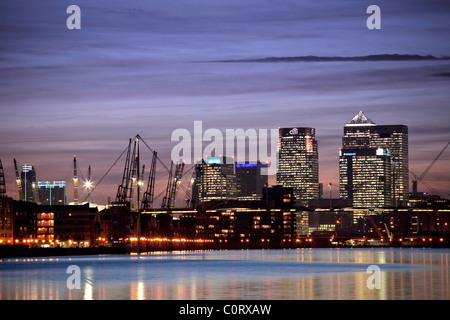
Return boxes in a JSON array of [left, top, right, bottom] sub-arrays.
[[0, 248, 450, 300]]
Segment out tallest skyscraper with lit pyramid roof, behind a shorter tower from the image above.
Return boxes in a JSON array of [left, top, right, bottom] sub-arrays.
[[340, 111, 409, 206]]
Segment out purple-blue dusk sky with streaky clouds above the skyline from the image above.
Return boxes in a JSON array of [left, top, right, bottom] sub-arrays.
[[0, 0, 450, 203]]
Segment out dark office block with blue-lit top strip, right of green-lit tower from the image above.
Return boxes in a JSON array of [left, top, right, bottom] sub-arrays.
[[236, 162, 268, 200]]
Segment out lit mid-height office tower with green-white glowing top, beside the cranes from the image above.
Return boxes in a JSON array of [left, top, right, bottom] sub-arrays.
[[193, 157, 238, 204]]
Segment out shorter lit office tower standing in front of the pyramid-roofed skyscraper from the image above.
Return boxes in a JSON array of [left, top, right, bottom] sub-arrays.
[[339, 148, 393, 208]]
